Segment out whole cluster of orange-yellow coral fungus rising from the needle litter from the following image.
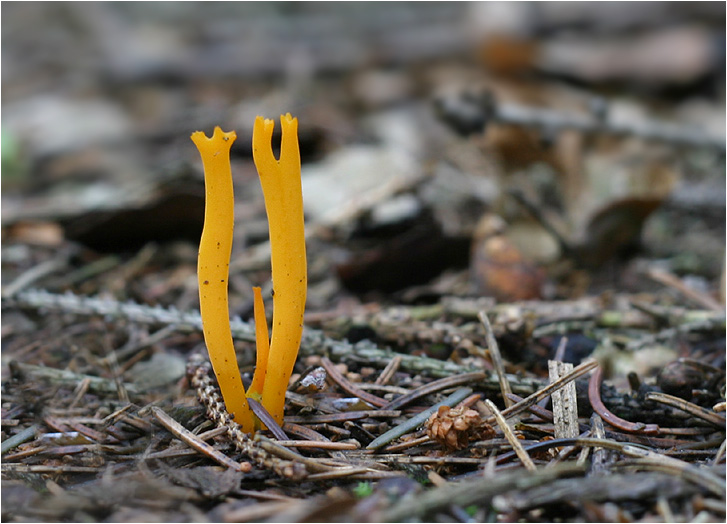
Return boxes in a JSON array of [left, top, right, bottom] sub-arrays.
[[192, 113, 308, 433]]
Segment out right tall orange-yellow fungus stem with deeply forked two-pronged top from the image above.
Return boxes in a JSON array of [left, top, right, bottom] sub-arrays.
[[252, 113, 308, 425]]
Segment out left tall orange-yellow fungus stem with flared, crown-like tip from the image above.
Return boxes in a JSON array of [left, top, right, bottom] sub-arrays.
[[192, 126, 254, 432]]
